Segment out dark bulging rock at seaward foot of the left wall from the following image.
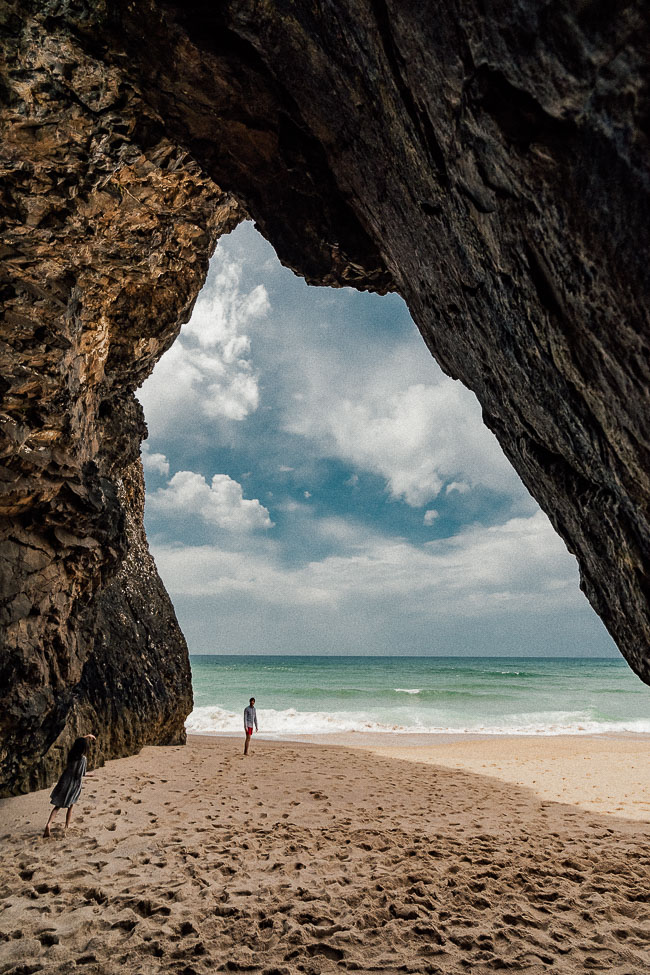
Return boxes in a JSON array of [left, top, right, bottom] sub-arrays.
[[71, 460, 192, 784]]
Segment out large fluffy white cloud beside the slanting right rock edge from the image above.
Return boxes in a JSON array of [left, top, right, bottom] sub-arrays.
[[286, 343, 526, 507]]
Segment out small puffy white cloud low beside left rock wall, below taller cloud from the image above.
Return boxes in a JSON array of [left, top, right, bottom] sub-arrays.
[[147, 471, 272, 531]]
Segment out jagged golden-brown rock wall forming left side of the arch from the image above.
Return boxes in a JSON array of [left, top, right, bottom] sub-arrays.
[[0, 5, 242, 790]]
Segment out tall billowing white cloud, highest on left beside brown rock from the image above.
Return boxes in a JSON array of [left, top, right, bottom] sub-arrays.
[[138, 258, 270, 437]]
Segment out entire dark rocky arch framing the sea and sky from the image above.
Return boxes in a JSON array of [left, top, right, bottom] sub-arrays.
[[0, 0, 650, 788]]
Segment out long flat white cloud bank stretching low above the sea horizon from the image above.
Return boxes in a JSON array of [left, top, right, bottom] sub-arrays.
[[155, 512, 584, 622]]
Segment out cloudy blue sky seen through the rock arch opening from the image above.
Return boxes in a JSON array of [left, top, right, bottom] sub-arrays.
[[138, 223, 618, 656]]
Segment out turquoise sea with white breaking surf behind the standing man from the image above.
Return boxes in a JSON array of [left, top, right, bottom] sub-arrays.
[[187, 655, 650, 737]]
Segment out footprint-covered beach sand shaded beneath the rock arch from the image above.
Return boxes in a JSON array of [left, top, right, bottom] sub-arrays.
[[0, 738, 650, 975]]
